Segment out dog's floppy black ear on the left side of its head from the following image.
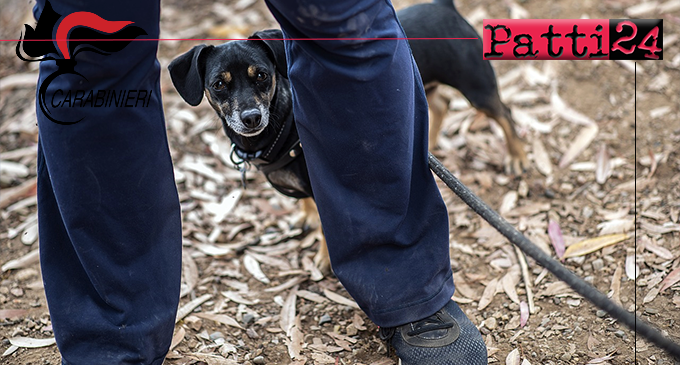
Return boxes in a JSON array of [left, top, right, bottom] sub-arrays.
[[168, 44, 213, 106]]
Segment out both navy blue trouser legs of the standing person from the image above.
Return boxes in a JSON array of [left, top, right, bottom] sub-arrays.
[[38, 0, 454, 365]]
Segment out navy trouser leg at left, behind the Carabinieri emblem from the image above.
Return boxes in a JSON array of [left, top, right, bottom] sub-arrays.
[[36, 0, 181, 365]]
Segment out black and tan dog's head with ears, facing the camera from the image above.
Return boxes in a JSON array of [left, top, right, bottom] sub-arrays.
[[168, 29, 287, 138]]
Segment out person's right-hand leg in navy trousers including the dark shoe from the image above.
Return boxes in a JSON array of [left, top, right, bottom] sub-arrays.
[[268, 0, 486, 365]]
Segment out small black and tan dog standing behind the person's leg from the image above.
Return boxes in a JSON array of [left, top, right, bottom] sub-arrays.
[[169, 0, 527, 272]]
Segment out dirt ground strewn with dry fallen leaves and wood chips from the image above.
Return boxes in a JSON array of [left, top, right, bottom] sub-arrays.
[[0, 0, 680, 365]]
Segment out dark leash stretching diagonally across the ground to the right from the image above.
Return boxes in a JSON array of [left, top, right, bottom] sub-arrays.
[[428, 153, 680, 360]]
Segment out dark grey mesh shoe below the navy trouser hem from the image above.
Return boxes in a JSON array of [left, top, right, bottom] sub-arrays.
[[380, 301, 488, 365]]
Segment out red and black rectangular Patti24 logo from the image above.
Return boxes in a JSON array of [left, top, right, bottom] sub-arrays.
[[483, 19, 663, 60]]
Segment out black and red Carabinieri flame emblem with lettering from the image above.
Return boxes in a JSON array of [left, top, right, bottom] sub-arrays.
[[16, 2, 153, 125]]
